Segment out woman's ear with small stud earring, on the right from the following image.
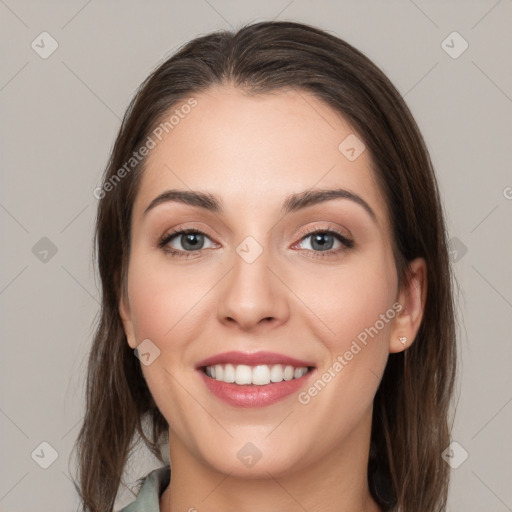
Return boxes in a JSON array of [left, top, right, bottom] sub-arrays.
[[389, 258, 427, 353]]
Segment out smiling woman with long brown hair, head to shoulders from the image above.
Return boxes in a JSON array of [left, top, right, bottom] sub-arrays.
[[72, 22, 456, 512]]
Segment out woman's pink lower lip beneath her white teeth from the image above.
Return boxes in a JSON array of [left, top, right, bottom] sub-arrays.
[[198, 369, 315, 407]]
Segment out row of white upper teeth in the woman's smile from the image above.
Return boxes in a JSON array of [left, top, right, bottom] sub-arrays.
[[205, 364, 308, 386]]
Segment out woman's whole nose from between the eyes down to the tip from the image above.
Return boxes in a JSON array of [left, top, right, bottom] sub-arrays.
[[218, 230, 287, 329]]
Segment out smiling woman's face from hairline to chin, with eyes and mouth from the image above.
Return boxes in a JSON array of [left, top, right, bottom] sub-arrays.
[[120, 86, 424, 477]]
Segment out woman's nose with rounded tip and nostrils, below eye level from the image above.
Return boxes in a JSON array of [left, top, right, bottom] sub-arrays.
[[218, 244, 290, 331]]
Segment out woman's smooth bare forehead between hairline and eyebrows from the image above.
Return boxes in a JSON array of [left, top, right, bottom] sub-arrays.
[[134, 86, 386, 229]]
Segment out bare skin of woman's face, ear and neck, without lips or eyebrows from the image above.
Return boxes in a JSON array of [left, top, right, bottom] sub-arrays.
[[119, 85, 426, 512]]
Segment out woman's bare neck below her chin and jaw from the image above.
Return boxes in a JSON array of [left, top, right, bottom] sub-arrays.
[[160, 413, 381, 512]]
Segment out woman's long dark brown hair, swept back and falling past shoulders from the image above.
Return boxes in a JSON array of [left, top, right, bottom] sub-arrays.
[[71, 22, 456, 512]]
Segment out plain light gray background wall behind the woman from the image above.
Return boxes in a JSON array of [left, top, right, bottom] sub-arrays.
[[0, 0, 512, 512]]
